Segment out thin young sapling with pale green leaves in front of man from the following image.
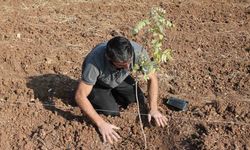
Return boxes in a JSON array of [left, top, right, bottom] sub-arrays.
[[132, 7, 174, 149]]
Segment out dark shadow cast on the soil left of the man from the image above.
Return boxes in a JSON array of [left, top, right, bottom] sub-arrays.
[[27, 74, 85, 120]]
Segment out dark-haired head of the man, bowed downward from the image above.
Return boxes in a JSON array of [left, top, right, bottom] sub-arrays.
[[106, 36, 133, 69]]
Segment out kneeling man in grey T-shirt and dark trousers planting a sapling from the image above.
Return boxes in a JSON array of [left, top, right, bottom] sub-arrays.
[[75, 36, 167, 144]]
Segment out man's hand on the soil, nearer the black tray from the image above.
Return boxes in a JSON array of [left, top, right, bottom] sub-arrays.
[[148, 110, 168, 127]]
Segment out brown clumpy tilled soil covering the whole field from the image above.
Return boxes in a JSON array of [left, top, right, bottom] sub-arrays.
[[0, 0, 250, 150]]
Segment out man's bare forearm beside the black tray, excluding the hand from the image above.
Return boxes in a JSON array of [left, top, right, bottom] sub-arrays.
[[148, 74, 158, 110]]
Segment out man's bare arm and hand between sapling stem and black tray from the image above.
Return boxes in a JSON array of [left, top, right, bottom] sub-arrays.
[[148, 73, 167, 127]]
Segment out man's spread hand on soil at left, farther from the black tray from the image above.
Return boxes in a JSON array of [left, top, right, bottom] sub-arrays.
[[98, 122, 121, 144]]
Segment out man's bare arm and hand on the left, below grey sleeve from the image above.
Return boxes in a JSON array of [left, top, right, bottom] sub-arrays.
[[75, 81, 120, 144]]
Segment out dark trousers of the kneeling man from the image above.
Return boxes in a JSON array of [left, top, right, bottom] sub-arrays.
[[88, 76, 145, 116]]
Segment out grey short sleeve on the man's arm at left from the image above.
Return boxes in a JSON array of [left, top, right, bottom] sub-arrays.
[[81, 63, 100, 85]]
